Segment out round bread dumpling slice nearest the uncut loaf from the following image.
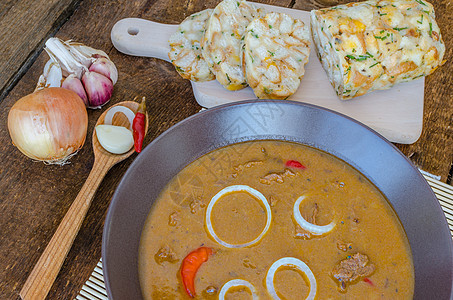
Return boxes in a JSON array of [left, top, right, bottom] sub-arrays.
[[242, 13, 310, 99]]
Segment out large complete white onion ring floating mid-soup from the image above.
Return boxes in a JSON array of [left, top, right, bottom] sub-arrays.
[[206, 185, 272, 248]]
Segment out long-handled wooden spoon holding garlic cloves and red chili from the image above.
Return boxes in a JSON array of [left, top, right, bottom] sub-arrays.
[[20, 101, 149, 300]]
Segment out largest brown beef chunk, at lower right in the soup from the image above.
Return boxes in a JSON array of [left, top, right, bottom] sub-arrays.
[[332, 253, 376, 291]]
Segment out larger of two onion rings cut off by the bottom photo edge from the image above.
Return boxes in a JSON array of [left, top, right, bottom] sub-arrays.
[[266, 257, 317, 300]]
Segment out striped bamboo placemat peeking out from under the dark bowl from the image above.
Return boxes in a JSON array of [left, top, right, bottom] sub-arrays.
[[76, 174, 453, 300]]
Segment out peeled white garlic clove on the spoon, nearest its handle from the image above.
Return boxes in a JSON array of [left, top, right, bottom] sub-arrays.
[[95, 124, 134, 154]]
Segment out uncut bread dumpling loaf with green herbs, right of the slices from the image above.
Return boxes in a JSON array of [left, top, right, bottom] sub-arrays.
[[311, 0, 445, 99]]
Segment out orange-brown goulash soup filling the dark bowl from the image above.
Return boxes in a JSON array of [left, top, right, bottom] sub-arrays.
[[139, 141, 414, 299]]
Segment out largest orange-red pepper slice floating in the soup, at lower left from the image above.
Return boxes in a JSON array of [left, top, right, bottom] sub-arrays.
[[181, 247, 212, 298]]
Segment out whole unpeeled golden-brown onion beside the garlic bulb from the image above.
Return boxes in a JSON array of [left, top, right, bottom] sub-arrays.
[[8, 87, 88, 164]]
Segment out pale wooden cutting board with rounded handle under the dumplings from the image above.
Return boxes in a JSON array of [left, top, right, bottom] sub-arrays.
[[111, 3, 425, 144]]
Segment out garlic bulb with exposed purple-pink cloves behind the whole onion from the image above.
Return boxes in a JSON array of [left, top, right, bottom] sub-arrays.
[[36, 38, 118, 108]]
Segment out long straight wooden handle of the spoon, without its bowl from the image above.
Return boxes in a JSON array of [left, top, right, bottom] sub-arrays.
[[20, 159, 111, 300]]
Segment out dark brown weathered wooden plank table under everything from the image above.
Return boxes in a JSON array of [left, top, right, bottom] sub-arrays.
[[0, 0, 453, 299]]
